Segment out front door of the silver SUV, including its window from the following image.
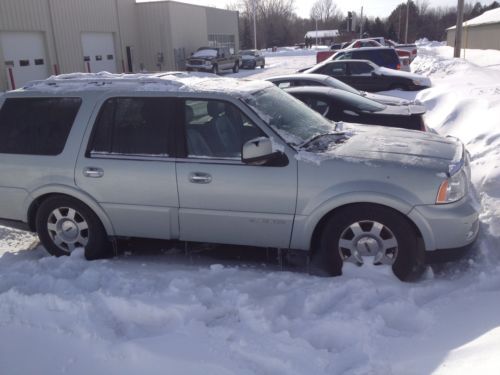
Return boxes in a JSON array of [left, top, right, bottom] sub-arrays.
[[177, 99, 297, 248]]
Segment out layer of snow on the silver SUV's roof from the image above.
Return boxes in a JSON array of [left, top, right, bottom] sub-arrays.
[[19, 71, 273, 95]]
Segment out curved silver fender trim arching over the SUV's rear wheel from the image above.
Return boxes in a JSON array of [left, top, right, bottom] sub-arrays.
[[25, 185, 115, 236]]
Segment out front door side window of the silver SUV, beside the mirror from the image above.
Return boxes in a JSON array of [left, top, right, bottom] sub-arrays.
[[184, 100, 265, 160]]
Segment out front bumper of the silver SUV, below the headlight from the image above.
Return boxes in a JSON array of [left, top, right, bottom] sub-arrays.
[[408, 192, 479, 260]]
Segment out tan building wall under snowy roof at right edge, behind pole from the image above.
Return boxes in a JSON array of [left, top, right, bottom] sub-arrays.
[[446, 23, 500, 50]]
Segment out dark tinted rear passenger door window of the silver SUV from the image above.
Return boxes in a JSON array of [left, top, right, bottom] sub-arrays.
[[89, 98, 173, 156]]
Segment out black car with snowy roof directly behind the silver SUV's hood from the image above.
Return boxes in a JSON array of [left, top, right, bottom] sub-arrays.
[[285, 86, 428, 131]]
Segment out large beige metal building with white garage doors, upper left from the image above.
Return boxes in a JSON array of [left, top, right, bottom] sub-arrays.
[[0, 0, 239, 91]]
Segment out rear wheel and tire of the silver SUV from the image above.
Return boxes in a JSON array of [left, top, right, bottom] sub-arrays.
[[36, 196, 113, 260]]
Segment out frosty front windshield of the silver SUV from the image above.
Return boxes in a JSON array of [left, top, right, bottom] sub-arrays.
[[245, 87, 335, 146]]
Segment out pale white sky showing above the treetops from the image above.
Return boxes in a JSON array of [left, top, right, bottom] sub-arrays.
[[137, 0, 493, 18]]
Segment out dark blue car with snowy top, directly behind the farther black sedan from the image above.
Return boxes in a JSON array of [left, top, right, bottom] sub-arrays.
[[327, 47, 401, 70]]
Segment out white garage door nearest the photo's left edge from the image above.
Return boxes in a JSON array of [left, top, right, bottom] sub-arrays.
[[0, 32, 49, 89]]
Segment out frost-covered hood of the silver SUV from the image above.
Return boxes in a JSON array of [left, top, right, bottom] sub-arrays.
[[314, 123, 464, 173]]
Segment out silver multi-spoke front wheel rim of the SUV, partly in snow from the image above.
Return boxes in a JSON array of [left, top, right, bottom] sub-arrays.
[[338, 220, 398, 266]]
